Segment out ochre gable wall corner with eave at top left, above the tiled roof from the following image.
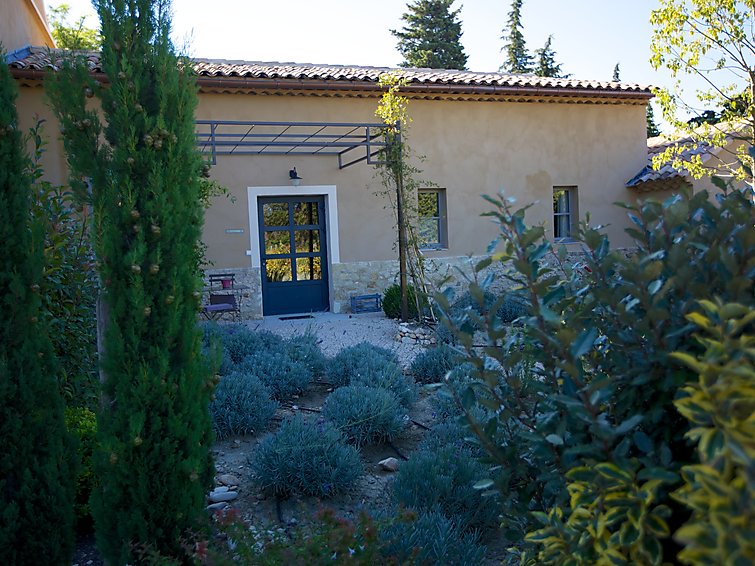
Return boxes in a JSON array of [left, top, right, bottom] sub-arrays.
[[0, 0, 54, 52]]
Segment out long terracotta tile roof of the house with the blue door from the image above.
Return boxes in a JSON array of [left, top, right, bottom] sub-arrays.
[[8, 47, 652, 99]]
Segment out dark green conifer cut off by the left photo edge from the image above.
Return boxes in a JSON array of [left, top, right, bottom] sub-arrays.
[[0, 46, 75, 564]]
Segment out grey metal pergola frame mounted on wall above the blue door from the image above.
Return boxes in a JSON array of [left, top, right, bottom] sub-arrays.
[[196, 120, 396, 169]]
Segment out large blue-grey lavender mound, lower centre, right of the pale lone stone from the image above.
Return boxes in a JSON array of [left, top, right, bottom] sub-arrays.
[[393, 445, 499, 531]]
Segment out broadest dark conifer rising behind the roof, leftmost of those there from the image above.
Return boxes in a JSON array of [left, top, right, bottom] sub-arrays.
[[391, 0, 467, 69]]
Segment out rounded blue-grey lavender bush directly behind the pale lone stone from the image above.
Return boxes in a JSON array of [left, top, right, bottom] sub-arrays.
[[322, 385, 406, 447]]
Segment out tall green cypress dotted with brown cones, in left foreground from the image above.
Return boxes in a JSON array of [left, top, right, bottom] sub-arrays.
[[49, 0, 213, 565]]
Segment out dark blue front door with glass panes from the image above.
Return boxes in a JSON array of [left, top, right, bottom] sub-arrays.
[[257, 196, 329, 315]]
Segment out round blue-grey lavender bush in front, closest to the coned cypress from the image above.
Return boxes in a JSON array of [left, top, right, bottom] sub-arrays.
[[210, 371, 278, 439]]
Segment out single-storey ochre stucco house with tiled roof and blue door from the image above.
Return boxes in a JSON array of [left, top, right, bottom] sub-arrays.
[[2, 2, 652, 318]]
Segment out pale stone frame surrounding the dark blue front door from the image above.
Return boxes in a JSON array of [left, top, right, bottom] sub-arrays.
[[246, 185, 341, 316]]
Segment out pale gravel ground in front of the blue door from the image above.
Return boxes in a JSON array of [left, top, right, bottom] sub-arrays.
[[246, 312, 424, 368]]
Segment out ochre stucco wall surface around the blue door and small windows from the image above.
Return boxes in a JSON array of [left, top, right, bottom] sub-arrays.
[[10, 82, 647, 268]]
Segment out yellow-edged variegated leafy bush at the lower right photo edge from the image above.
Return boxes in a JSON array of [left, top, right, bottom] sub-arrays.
[[672, 301, 755, 564]]
